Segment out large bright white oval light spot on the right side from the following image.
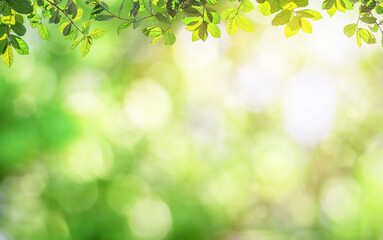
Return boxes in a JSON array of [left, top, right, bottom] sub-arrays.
[[283, 69, 336, 146]]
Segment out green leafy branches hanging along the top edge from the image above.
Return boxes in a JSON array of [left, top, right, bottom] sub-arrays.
[[0, 0, 383, 67]]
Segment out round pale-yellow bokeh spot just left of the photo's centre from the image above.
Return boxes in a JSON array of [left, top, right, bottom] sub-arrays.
[[124, 80, 172, 130]]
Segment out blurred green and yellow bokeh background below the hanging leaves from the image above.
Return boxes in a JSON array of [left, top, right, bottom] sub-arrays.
[[0, 2, 383, 240]]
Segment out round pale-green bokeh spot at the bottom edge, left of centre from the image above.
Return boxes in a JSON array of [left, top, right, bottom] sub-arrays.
[[128, 199, 172, 239]]
